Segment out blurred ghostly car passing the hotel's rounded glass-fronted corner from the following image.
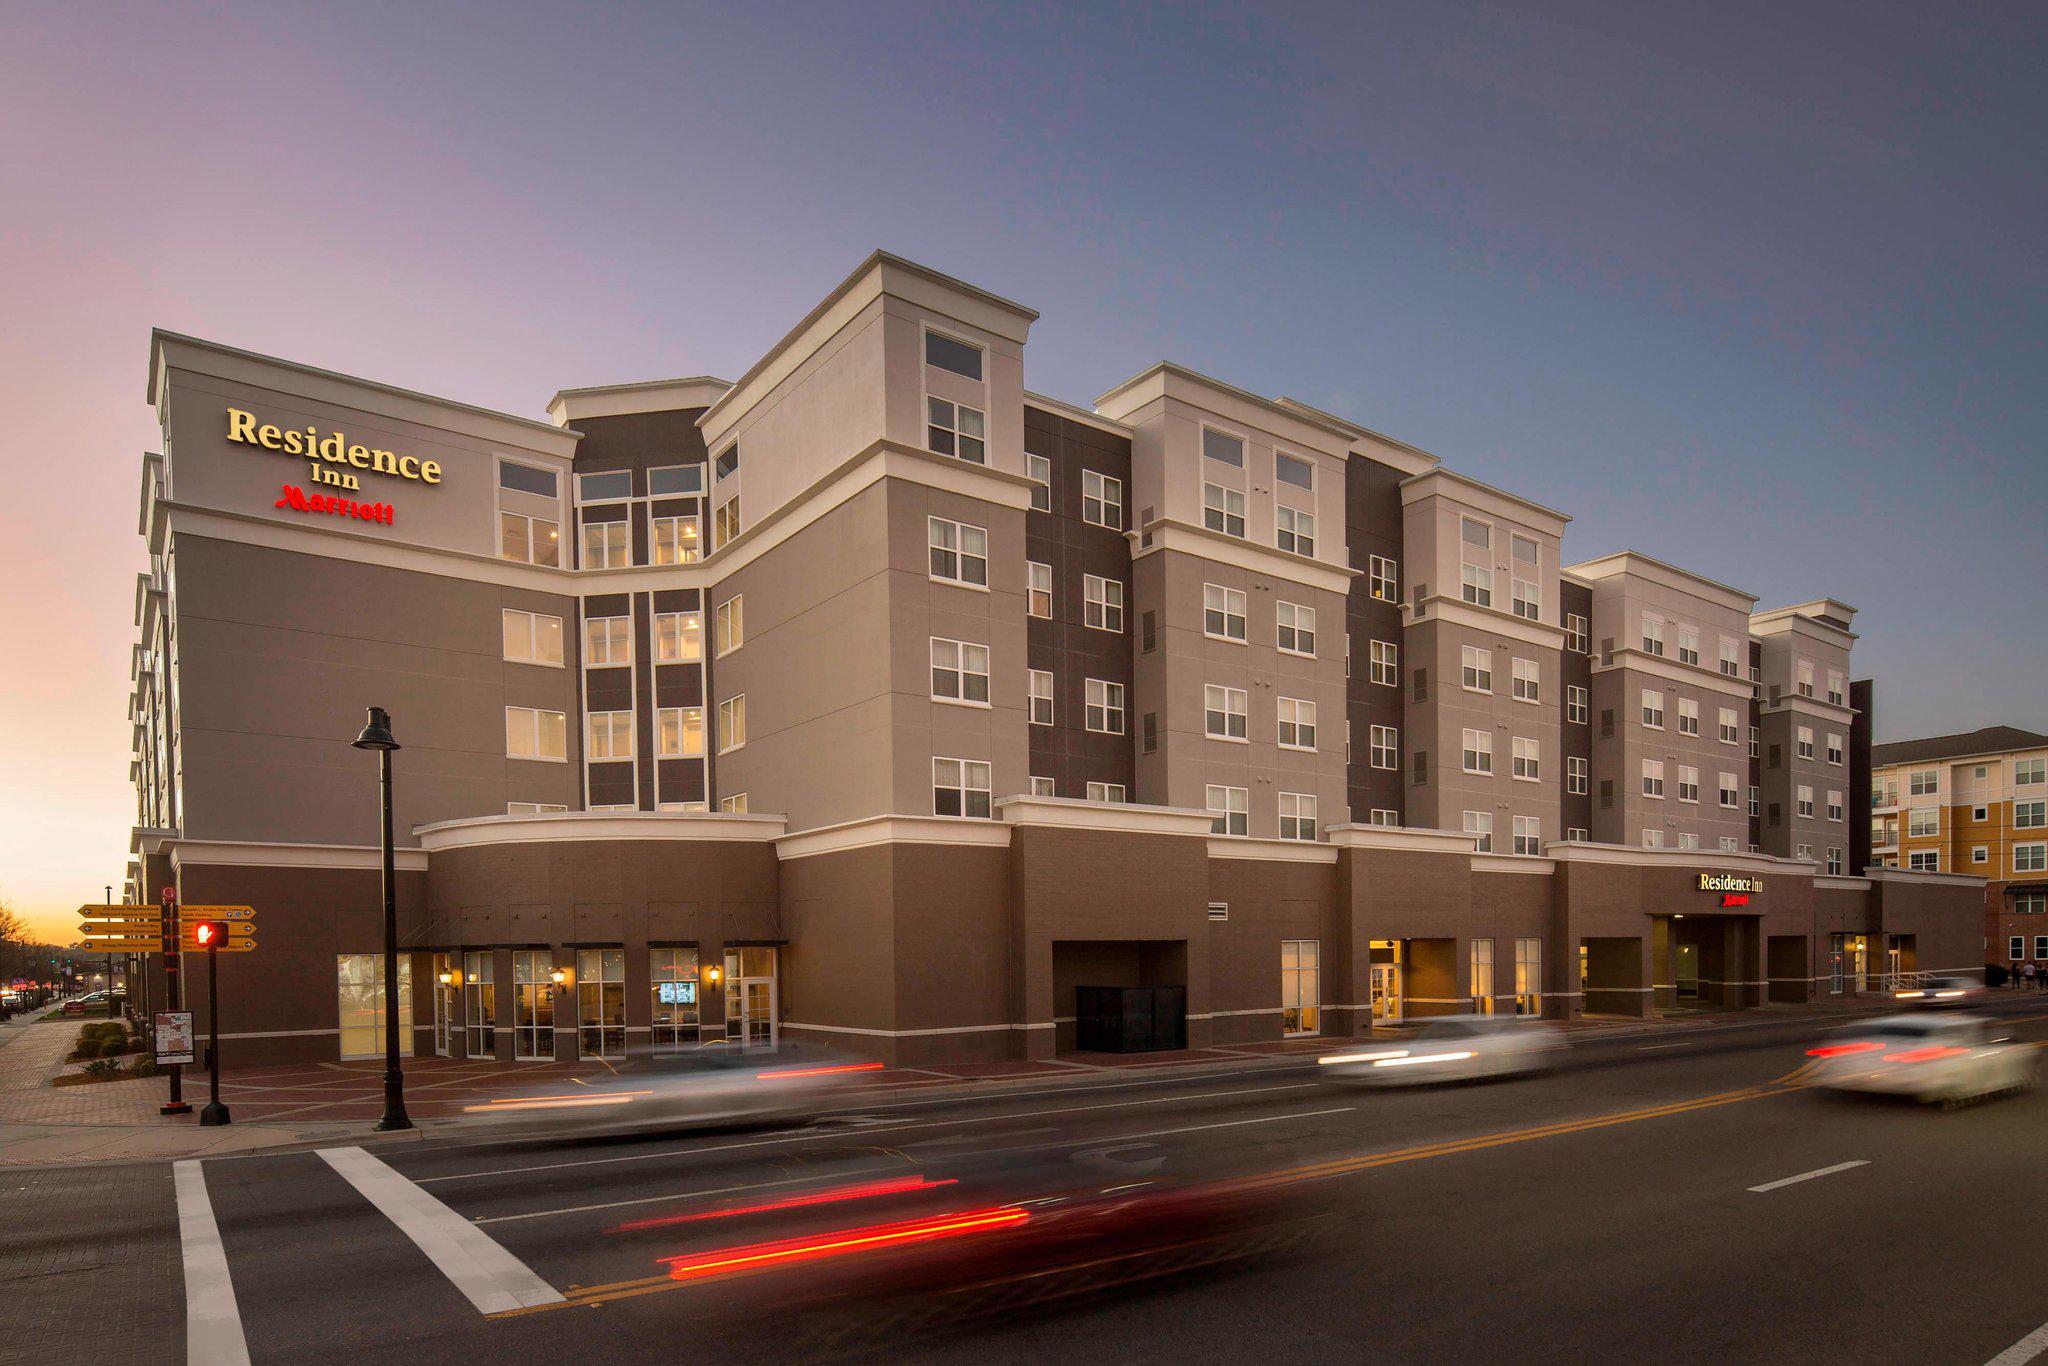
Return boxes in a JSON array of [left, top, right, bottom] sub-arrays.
[[463, 1044, 883, 1135]]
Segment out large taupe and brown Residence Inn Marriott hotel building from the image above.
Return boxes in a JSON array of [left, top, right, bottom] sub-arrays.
[[129, 252, 1982, 1063]]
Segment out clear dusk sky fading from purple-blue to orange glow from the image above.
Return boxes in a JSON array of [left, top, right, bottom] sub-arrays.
[[0, 0, 2048, 938]]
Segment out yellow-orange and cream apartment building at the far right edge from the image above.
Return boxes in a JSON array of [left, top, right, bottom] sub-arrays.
[[1870, 725, 2048, 971]]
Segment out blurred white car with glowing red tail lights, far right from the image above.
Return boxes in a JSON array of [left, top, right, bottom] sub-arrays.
[[1806, 1014, 2040, 1106]]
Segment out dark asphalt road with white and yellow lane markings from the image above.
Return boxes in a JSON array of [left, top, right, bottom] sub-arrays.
[[0, 997, 2048, 1366]]
